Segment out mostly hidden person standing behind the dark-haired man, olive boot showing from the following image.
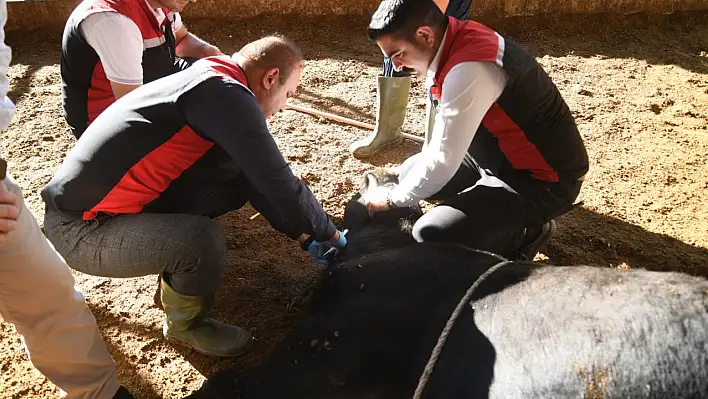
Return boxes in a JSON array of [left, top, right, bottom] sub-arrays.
[[349, 0, 472, 158]]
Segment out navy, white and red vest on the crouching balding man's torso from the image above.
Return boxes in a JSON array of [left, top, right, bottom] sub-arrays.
[[42, 56, 256, 220]]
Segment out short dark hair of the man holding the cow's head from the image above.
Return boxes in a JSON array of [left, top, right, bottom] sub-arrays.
[[366, 0, 447, 41]]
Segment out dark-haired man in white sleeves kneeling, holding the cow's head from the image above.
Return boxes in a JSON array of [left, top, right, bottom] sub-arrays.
[[366, 0, 588, 260]]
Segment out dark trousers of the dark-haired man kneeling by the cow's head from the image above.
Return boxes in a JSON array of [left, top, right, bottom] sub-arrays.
[[413, 159, 582, 257]]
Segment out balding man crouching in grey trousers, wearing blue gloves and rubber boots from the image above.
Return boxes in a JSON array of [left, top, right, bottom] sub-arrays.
[[42, 36, 346, 356]]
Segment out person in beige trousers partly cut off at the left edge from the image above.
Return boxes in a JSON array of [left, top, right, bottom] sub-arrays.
[[0, 0, 132, 399]]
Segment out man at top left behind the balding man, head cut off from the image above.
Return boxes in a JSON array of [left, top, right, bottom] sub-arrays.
[[61, 0, 222, 138]]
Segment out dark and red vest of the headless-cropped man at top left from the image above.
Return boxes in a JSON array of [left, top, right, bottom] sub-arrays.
[[61, 0, 178, 139]]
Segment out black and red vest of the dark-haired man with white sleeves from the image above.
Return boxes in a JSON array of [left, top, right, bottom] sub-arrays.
[[430, 18, 588, 187]]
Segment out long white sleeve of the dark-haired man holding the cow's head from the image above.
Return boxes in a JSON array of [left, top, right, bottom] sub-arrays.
[[391, 62, 507, 206]]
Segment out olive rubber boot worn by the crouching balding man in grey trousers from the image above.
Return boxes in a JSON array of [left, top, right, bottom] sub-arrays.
[[161, 278, 253, 357]]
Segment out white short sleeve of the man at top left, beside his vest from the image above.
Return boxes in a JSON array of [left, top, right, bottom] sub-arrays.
[[80, 12, 143, 85]]
